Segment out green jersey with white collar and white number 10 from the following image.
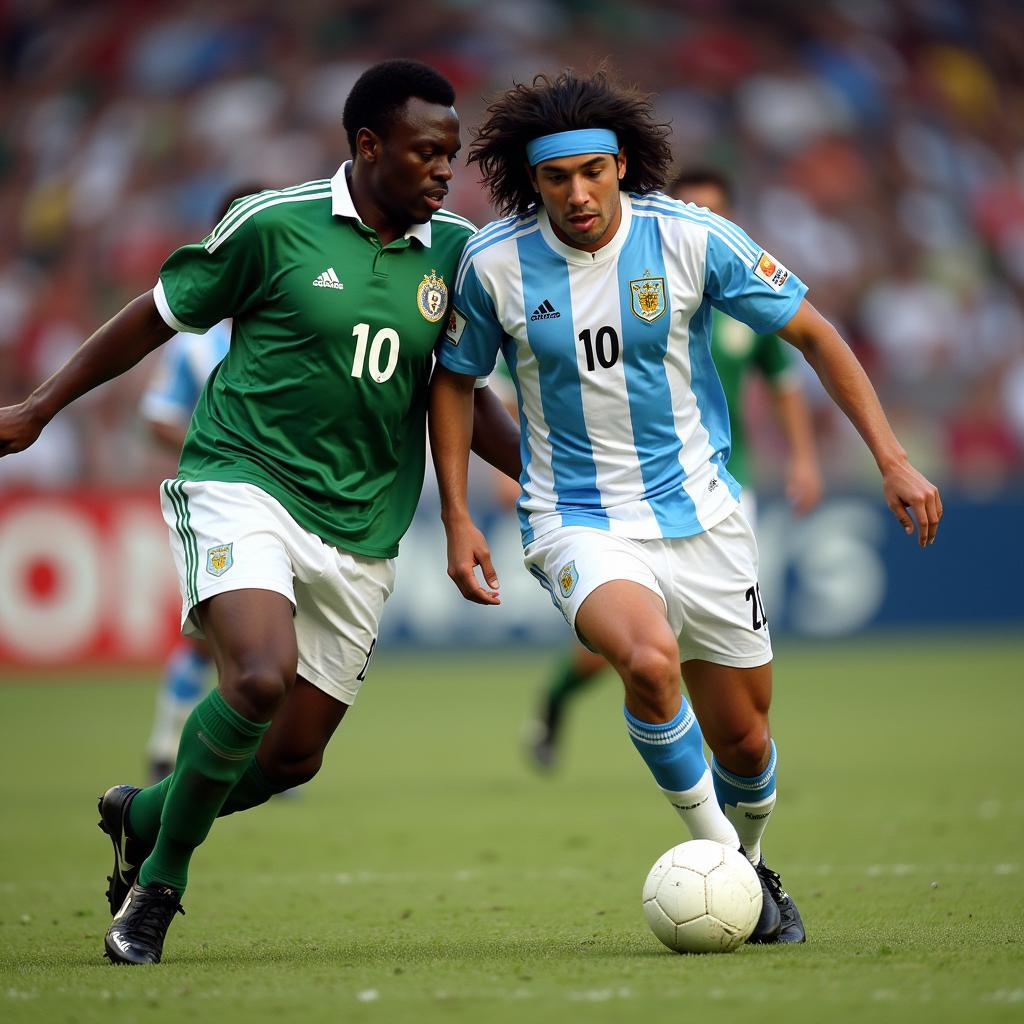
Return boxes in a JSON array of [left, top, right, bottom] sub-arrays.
[[154, 164, 474, 558]]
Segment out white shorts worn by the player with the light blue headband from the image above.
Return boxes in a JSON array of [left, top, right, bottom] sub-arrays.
[[523, 509, 772, 669]]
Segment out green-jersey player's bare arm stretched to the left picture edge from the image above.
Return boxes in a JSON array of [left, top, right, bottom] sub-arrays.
[[0, 292, 174, 456]]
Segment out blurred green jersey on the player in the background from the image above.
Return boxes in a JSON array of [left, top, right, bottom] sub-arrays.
[[711, 309, 795, 487]]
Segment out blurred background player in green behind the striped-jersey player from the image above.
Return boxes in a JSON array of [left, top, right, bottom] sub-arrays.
[[528, 168, 822, 769]]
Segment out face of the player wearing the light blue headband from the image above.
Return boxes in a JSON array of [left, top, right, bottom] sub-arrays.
[[530, 151, 626, 253]]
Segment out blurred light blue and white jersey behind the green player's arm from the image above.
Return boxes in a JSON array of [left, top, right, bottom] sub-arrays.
[[139, 319, 231, 427]]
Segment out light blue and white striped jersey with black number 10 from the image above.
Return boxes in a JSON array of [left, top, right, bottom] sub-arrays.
[[438, 193, 807, 544]]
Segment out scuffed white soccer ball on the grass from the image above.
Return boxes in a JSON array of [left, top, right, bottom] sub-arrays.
[[643, 839, 761, 953]]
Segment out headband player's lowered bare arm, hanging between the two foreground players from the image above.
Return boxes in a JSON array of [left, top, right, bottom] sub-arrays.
[[429, 364, 501, 604]]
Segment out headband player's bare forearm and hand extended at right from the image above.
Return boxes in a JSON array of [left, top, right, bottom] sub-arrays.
[[778, 299, 942, 548]]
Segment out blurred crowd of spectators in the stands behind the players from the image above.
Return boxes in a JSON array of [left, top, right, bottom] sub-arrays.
[[0, 0, 1024, 497]]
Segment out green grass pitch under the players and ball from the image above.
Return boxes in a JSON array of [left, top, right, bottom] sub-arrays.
[[0, 634, 1024, 1024]]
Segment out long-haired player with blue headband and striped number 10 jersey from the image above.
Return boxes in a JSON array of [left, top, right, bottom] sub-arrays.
[[430, 66, 941, 942]]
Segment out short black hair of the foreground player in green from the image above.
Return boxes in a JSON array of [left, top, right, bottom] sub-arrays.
[[341, 58, 455, 157]]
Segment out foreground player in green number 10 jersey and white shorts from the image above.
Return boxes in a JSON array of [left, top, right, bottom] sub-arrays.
[[0, 60, 520, 964]]
